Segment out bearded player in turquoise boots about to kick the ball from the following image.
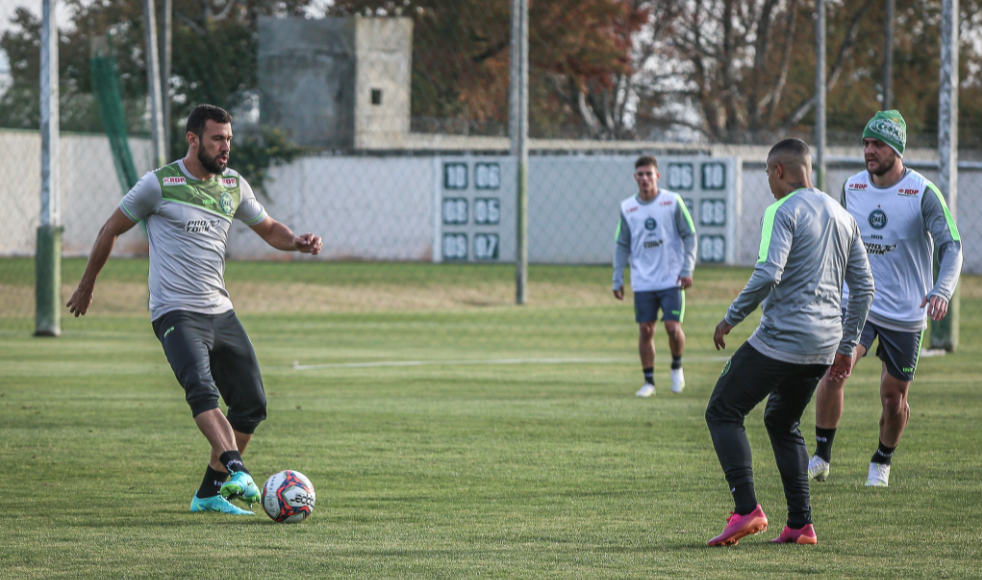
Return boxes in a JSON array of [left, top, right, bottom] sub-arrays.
[[68, 105, 322, 515]]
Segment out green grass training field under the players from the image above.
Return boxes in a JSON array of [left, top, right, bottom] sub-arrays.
[[0, 260, 982, 579]]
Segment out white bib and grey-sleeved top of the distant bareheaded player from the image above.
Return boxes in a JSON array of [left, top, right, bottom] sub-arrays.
[[613, 189, 696, 292]]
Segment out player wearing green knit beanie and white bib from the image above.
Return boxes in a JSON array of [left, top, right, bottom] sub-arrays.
[[808, 111, 962, 487]]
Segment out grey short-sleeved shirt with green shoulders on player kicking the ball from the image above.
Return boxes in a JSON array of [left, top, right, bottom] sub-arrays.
[[119, 160, 266, 320]]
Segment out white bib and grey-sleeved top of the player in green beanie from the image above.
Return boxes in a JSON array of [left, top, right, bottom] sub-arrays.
[[842, 169, 963, 332]]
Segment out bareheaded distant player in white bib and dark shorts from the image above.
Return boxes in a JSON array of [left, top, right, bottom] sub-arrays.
[[613, 155, 696, 397]]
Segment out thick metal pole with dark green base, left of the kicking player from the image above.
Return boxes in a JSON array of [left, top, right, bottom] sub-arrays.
[[34, 0, 62, 336]]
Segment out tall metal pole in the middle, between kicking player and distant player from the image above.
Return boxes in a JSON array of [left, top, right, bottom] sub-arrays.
[[509, 0, 529, 304]]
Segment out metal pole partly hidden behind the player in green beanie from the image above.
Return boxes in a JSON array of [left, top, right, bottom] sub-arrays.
[[931, 0, 961, 352]]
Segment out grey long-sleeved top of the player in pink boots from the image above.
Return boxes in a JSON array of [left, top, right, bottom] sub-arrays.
[[725, 189, 873, 364]]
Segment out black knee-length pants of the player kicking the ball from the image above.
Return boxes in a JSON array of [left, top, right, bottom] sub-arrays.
[[153, 310, 266, 434]]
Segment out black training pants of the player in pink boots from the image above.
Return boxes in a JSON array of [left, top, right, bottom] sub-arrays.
[[706, 342, 829, 527]]
